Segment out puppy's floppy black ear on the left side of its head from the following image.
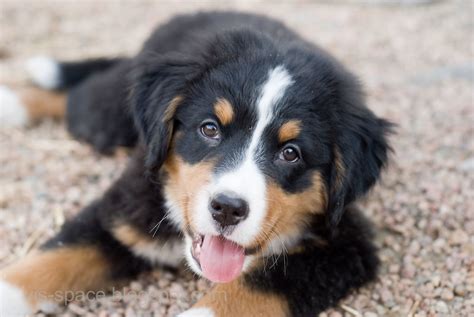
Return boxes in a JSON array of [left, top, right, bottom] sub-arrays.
[[131, 54, 201, 170]]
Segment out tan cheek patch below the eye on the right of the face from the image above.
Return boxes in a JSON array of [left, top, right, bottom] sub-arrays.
[[250, 172, 327, 248]]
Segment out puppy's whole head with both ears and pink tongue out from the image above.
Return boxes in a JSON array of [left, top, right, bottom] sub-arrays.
[[133, 33, 390, 282]]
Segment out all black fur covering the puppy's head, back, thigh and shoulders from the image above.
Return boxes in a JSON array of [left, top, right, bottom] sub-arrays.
[[40, 12, 391, 316]]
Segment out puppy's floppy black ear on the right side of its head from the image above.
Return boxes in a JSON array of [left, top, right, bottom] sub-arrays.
[[328, 89, 393, 227]]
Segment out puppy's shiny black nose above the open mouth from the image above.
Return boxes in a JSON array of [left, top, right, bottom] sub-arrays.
[[209, 194, 249, 227]]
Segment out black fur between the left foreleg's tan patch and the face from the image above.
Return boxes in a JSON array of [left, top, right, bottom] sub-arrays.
[[43, 149, 179, 278]]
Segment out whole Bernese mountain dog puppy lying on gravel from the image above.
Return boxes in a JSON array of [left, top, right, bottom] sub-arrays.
[[0, 12, 391, 316]]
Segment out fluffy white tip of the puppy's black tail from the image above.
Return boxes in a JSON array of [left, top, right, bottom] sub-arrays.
[[26, 56, 61, 89]]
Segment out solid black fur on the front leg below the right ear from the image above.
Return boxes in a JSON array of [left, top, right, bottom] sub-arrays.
[[246, 207, 379, 316]]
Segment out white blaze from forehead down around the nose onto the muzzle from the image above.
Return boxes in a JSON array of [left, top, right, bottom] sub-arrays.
[[195, 66, 293, 245]]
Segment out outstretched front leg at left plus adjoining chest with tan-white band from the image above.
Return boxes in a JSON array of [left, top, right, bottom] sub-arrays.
[[0, 151, 178, 316]]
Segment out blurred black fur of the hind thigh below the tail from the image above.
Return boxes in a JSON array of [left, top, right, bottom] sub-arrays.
[[66, 60, 138, 153]]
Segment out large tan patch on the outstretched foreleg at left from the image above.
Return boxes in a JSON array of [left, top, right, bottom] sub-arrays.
[[0, 247, 110, 307]]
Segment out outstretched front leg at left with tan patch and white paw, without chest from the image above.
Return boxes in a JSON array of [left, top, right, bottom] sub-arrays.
[[0, 202, 150, 316]]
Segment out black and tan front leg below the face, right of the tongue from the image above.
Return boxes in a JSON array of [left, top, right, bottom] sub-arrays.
[[181, 210, 378, 317]]
